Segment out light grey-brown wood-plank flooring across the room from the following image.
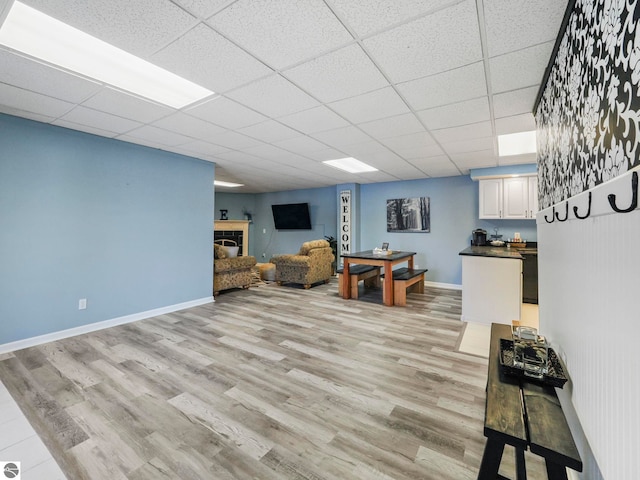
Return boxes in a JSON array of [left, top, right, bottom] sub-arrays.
[[0, 280, 544, 480]]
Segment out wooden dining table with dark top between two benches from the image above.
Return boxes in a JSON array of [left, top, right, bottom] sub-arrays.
[[340, 250, 416, 307]]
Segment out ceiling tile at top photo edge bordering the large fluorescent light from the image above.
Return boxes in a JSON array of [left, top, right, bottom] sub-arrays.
[[27, 0, 196, 57]]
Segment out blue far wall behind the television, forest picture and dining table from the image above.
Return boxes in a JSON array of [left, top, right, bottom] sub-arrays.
[[216, 176, 537, 285]]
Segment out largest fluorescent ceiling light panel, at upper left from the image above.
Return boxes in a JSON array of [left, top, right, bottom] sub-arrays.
[[0, 2, 214, 108]]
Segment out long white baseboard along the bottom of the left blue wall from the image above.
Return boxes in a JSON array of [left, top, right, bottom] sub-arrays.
[[0, 297, 215, 354]]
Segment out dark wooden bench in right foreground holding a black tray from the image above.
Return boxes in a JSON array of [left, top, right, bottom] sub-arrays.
[[478, 323, 582, 480]]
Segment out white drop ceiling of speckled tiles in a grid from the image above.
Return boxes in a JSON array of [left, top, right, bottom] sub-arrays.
[[0, 0, 567, 193]]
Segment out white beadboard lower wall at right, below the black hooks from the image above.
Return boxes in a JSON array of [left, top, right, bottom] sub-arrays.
[[537, 169, 640, 480]]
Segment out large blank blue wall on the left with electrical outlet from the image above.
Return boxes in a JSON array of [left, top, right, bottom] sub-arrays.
[[0, 114, 214, 344]]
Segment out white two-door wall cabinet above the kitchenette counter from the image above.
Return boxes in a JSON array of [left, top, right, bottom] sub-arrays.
[[479, 177, 538, 220]]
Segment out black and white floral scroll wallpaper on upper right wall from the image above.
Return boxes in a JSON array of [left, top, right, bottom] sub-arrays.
[[536, 0, 640, 210]]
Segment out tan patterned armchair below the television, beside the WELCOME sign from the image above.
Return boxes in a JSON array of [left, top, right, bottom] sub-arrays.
[[271, 240, 334, 288]]
